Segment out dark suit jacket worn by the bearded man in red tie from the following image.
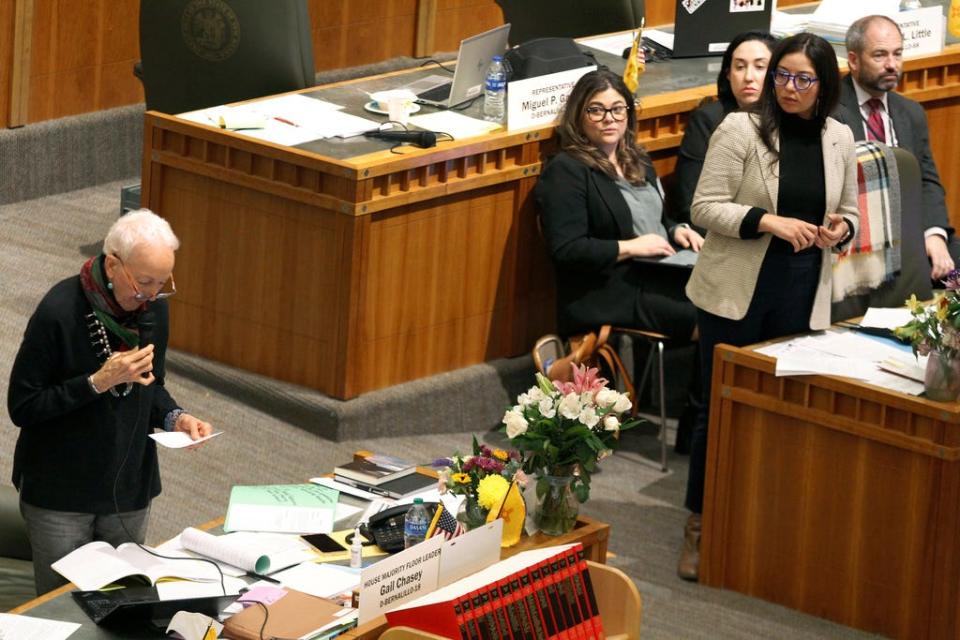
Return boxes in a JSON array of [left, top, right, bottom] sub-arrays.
[[834, 75, 953, 236]]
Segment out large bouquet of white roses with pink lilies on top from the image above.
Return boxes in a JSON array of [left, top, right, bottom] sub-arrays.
[[502, 365, 640, 502]]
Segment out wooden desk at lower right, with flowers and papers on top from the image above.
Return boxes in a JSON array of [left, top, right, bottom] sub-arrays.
[[700, 346, 960, 639]]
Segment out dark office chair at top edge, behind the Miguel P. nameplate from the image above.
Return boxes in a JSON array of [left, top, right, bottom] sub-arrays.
[[496, 0, 645, 45]]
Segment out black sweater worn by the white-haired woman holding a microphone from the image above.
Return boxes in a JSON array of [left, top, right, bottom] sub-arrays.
[[7, 276, 177, 514]]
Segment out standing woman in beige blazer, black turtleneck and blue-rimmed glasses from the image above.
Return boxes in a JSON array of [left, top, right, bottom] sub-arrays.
[[678, 33, 858, 580]]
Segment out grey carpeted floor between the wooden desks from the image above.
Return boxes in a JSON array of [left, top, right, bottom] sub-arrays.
[[0, 181, 873, 639]]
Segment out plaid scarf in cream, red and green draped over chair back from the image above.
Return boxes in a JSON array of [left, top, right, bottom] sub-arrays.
[[833, 142, 901, 302]]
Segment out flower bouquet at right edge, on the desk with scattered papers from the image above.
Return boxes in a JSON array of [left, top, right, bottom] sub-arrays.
[[894, 269, 960, 359]]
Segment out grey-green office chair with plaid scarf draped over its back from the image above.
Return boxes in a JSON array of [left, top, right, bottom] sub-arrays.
[[830, 147, 933, 322]]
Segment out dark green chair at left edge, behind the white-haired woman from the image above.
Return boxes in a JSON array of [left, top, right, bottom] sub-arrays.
[[0, 485, 37, 611]]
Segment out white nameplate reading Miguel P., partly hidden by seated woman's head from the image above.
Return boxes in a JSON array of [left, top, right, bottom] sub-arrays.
[[507, 66, 596, 131]]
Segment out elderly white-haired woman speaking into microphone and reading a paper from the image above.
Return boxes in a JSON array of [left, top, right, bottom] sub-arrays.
[[7, 209, 212, 594]]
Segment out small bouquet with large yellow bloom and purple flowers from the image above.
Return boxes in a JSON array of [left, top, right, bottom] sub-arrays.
[[433, 436, 526, 529]]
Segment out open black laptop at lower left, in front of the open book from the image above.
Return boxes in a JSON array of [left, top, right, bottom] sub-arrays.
[[70, 587, 238, 629]]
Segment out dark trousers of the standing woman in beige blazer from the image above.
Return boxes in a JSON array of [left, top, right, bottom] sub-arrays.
[[686, 251, 823, 513]]
